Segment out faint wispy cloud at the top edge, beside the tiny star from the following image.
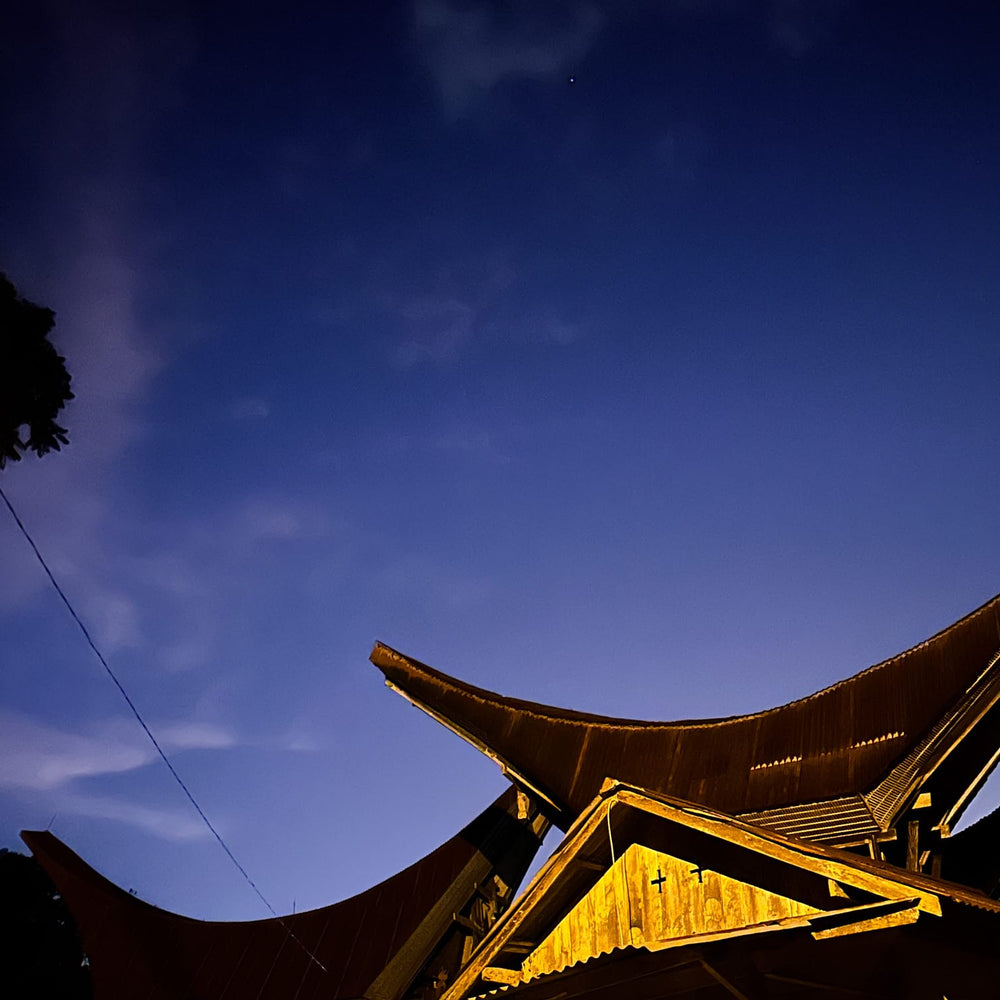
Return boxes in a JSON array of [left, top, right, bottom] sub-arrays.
[[414, 0, 604, 119]]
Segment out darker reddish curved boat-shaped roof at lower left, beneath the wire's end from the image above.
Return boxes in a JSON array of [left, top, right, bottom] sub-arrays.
[[21, 788, 552, 1000]]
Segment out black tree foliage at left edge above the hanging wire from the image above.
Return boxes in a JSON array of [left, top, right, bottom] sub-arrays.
[[0, 274, 73, 469]]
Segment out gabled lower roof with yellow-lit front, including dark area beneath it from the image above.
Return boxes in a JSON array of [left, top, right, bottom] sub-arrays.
[[442, 780, 1000, 1000]]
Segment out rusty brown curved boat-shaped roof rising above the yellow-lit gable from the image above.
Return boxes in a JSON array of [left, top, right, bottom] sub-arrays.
[[371, 596, 1000, 829]]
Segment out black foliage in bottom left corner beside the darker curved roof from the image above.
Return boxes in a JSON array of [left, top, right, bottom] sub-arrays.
[[0, 848, 93, 1000]]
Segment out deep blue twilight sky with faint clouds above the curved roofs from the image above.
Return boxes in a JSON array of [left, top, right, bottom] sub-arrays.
[[0, 0, 1000, 917]]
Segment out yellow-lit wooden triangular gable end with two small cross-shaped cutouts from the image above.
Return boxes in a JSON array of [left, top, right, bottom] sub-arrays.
[[442, 781, 960, 1000]]
